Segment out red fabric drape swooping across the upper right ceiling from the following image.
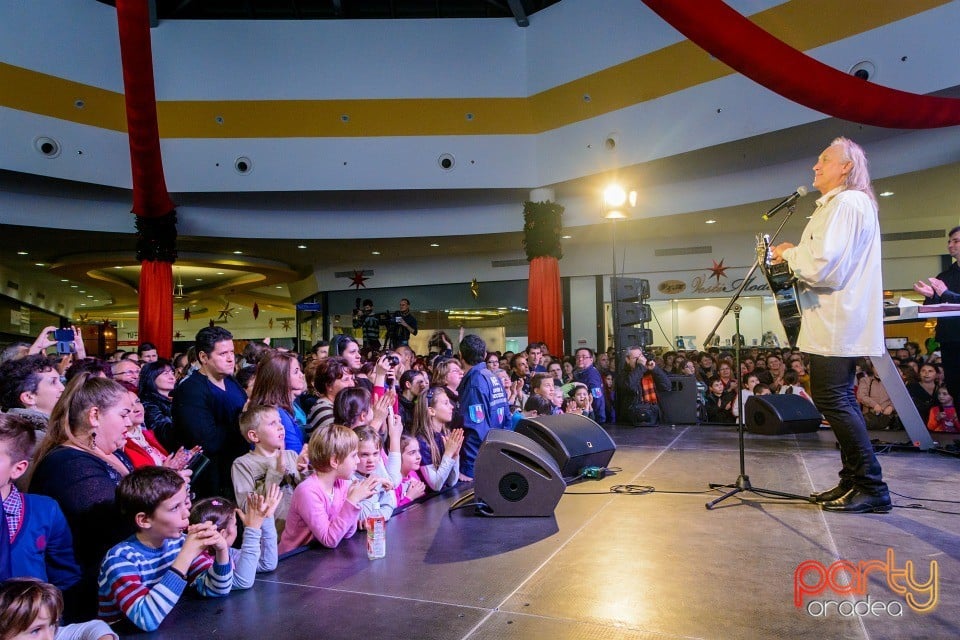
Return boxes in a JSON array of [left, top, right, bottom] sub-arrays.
[[643, 0, 960, 129]]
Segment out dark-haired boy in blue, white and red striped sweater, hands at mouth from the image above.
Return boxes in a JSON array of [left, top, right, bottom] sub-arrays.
[[99, 467, 233, 631]]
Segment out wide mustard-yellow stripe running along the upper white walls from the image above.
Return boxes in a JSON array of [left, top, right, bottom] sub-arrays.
[[0, 0, 949, 138]]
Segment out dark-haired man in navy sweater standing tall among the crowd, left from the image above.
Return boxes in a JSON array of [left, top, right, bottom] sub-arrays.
[[173, 326, 249, 498]]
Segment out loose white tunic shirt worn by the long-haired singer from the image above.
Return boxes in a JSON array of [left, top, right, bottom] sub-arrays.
[[783, 187, 884, 357]]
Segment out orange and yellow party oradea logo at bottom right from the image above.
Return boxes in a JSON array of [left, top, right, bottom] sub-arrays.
[[793, 548, 940, 618]]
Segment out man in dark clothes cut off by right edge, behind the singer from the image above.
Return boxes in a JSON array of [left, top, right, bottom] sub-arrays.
[[913, 226, 960, 400]]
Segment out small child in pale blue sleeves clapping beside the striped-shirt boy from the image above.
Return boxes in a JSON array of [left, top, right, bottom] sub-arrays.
[[190, 485, 280, 590]]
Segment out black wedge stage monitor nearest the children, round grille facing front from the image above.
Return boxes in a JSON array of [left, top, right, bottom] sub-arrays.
[[473, 429, 567, 516]]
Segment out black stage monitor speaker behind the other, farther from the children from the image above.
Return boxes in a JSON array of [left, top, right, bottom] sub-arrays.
[[516, 413, 617, 479]]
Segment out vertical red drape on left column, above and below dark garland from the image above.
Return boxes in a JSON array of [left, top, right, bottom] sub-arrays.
[[117, 0, 174, 358]]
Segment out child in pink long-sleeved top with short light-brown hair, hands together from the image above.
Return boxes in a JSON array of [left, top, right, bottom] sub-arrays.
[[279, 424, 381, 554]]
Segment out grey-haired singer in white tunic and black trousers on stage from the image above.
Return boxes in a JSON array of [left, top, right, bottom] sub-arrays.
[[773, 138, 891, 513]]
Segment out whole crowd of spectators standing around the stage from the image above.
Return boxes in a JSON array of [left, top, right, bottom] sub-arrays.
[[0, 314, 957, 637]]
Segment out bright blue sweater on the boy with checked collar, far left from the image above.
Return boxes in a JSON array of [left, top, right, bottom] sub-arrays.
[[7, 493, 80, 591]]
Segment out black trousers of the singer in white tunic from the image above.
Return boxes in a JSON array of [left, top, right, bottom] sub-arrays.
[[810, 354, 887, 495]]
